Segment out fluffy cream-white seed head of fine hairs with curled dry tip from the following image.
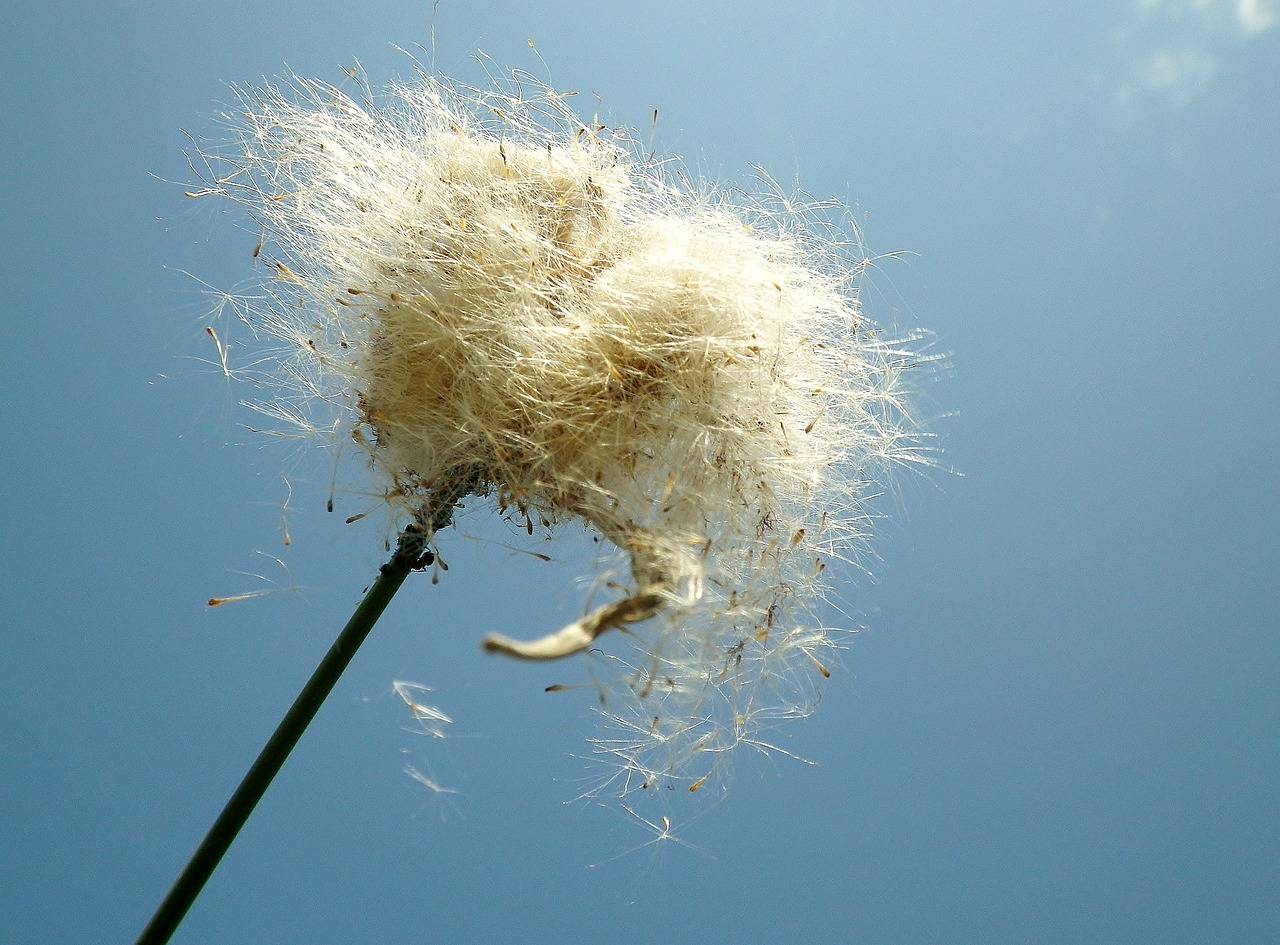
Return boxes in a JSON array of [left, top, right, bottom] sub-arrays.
[[192, 62, 920, 791]]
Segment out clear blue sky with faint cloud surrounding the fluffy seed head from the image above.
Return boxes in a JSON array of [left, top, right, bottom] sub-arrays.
[[0, 0, 1280, 945]]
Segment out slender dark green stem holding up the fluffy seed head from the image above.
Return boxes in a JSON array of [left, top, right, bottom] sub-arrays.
[[137, 522, 430, 945]]
